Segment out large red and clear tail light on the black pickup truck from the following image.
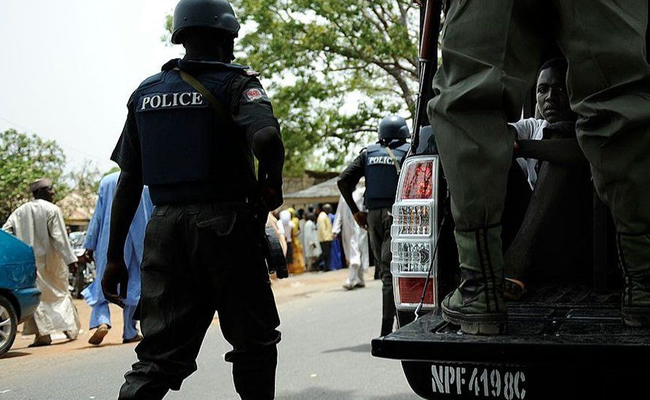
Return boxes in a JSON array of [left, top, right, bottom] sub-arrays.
[[391, 155, 438, 310]]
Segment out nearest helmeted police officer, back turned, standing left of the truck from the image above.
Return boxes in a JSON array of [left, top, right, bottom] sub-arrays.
[[102, 0, 284, 400]]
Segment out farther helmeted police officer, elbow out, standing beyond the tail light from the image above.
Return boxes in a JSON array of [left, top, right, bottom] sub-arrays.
[[338, 115, 410, 336]]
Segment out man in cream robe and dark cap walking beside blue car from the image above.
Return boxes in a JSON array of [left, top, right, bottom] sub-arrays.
[[2, 178, 81, 347]]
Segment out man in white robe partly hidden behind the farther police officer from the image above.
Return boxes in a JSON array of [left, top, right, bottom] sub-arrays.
[[332, 186, 370, 290]]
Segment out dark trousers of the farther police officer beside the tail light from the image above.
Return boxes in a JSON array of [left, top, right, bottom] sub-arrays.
[[368, 208, 395, 336]]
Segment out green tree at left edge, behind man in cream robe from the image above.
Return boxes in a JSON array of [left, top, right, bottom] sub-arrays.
[[0, 129, 67, 223]]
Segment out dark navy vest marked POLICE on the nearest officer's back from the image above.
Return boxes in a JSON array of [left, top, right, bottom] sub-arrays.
[[132, 64, 255, 204]]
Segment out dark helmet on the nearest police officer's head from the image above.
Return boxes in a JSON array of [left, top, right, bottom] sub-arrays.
[[172, 0, 239, 44]]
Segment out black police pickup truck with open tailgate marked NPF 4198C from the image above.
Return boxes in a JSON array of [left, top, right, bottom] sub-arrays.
[[372, 0, 650, 400]]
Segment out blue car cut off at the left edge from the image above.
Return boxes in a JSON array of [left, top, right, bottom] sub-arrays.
[[0, 231, 41, 356]]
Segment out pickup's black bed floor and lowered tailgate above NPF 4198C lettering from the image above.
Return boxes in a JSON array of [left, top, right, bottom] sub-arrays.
[[372, 286, 650, 399]]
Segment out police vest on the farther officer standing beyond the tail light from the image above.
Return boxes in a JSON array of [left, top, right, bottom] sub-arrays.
[[365, 143, 410, 210]]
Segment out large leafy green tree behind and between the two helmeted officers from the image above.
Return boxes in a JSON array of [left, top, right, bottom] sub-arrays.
[[167, 0, 419, 175]]
